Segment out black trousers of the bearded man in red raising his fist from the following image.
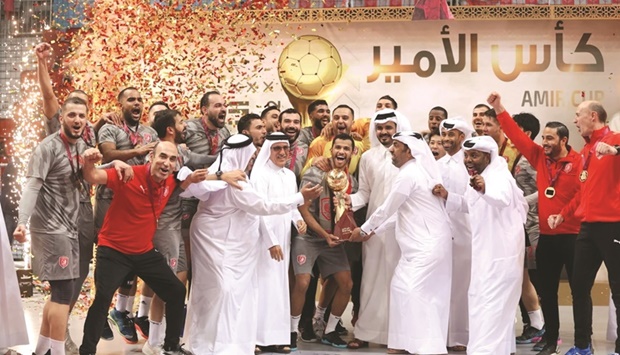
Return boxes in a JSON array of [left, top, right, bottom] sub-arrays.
[[536, 234, 577, 343]]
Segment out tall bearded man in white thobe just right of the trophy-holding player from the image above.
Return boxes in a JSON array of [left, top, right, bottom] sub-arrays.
[[348, 109, 410, 349]]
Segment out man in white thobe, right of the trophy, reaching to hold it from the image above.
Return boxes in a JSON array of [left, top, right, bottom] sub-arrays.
[[352, 131, 452, 354]]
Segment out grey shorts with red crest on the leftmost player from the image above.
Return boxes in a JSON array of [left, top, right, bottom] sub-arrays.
[[30, 232, 80, 281]]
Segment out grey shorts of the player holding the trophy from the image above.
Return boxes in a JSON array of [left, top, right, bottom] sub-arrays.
[[291, 237, 350, 278]]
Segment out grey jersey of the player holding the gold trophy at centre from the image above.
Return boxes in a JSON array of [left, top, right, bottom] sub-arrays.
[[299, 166, 357, 242]]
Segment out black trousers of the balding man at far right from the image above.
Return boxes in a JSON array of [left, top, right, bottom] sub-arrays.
[[572, 222, 620, 352]]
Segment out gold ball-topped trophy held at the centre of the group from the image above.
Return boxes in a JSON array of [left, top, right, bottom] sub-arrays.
[[327, 169, 357, 240]]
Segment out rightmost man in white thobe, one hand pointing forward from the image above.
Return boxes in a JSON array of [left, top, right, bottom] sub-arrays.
[[433, 136, 527, 355]]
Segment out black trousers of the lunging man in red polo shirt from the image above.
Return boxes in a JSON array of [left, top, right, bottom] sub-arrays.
[[80, 246, 185, 354]]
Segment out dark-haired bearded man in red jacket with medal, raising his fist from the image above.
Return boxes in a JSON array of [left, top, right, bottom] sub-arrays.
[[489, 93, 582, 355]]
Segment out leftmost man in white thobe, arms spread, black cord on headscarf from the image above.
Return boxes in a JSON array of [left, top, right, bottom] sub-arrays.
[[179, 134, 321, 355]]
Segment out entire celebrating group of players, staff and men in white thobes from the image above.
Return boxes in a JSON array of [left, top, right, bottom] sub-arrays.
[[3, 43, 620, 355]]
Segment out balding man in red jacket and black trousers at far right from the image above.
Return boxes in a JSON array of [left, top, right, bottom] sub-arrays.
[[549, 101, 620, 355]]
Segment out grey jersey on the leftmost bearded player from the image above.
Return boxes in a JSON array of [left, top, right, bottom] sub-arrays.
[[25, 132, 87, 235]]
